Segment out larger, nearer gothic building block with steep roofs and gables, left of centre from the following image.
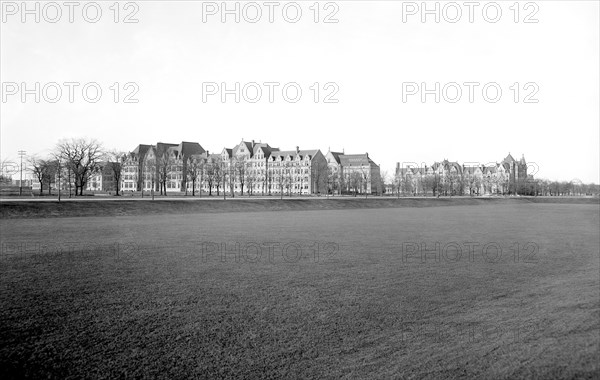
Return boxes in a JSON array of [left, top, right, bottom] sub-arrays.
[[115, 140, 382, 195]]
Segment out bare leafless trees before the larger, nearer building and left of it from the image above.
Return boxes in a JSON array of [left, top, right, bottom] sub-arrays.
[[11, 138, 368, 197]]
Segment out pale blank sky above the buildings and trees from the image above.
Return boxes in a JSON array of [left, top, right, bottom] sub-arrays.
[[0, 1, 600, 183]]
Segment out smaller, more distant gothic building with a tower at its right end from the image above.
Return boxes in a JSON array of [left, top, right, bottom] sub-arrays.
[[395, 153, 531, 195]]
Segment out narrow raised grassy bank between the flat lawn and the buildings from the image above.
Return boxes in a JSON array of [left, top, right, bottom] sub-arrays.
[[0, 196, 600, 219]]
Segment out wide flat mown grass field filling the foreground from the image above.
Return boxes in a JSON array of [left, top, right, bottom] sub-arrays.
[[0, 200, 600, 379]]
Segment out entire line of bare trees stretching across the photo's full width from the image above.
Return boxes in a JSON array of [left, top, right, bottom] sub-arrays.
[[0, 138, 600, 197]]
